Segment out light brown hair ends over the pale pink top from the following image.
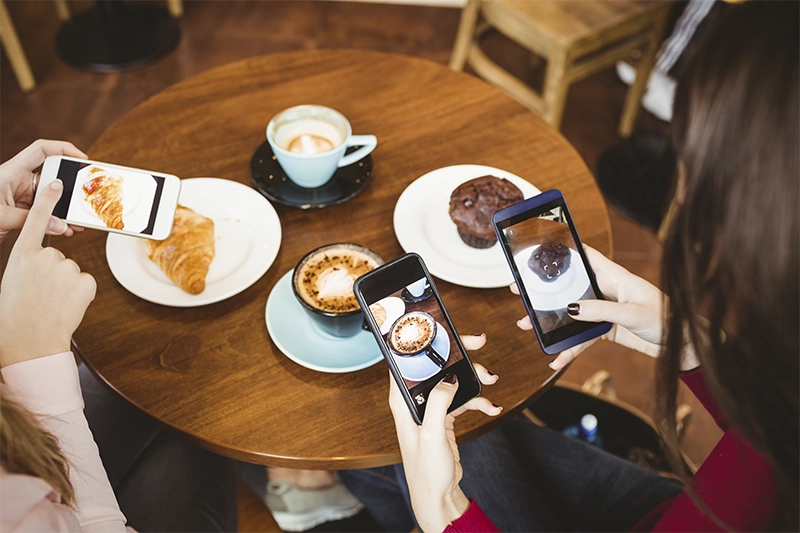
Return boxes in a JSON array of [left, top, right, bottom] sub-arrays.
[[0, 385, 75, 505]]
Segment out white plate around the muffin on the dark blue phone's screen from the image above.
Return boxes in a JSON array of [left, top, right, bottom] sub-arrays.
[[514, 244, 589, 311]]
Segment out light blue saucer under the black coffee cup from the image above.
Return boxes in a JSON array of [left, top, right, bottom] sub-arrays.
[[265, 270, 383, 373]]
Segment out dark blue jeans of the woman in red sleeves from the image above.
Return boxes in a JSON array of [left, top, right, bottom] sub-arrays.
[[339, 419, 682, 533]]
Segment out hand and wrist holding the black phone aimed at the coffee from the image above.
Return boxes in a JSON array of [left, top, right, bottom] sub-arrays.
[[389, 336, 503, 533]]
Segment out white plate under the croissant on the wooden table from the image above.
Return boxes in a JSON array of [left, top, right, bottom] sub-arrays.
[[106, 178, 281, 307]]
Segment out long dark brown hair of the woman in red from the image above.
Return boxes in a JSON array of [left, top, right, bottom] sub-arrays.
[[657, 0, 800, 531]]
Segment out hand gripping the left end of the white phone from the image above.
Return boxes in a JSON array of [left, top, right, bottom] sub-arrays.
[[0, 139, 86, 241]]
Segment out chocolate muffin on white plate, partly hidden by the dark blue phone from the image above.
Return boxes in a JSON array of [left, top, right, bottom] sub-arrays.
[[450, 176, 523, 248]]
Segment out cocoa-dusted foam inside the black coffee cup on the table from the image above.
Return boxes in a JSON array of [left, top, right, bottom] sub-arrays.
[[295, 248, 378, 313]]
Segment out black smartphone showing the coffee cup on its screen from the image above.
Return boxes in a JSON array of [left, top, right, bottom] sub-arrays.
[[353, 253, 481, 424]]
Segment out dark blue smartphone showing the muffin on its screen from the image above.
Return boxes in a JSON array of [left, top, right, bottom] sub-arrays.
[[492, 190, 611, 355]]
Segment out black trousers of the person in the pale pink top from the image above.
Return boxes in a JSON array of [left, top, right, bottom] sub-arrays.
[[80, 365, 238, 533]]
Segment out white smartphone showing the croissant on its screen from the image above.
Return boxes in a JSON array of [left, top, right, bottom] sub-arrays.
[[36, 155, 181, 241]]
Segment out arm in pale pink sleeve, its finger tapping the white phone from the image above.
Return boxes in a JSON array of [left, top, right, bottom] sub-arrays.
[[0, 180, 125, 533]]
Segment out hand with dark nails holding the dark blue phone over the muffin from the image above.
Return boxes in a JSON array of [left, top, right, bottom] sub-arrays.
[[511, 246, 664, 370]]
